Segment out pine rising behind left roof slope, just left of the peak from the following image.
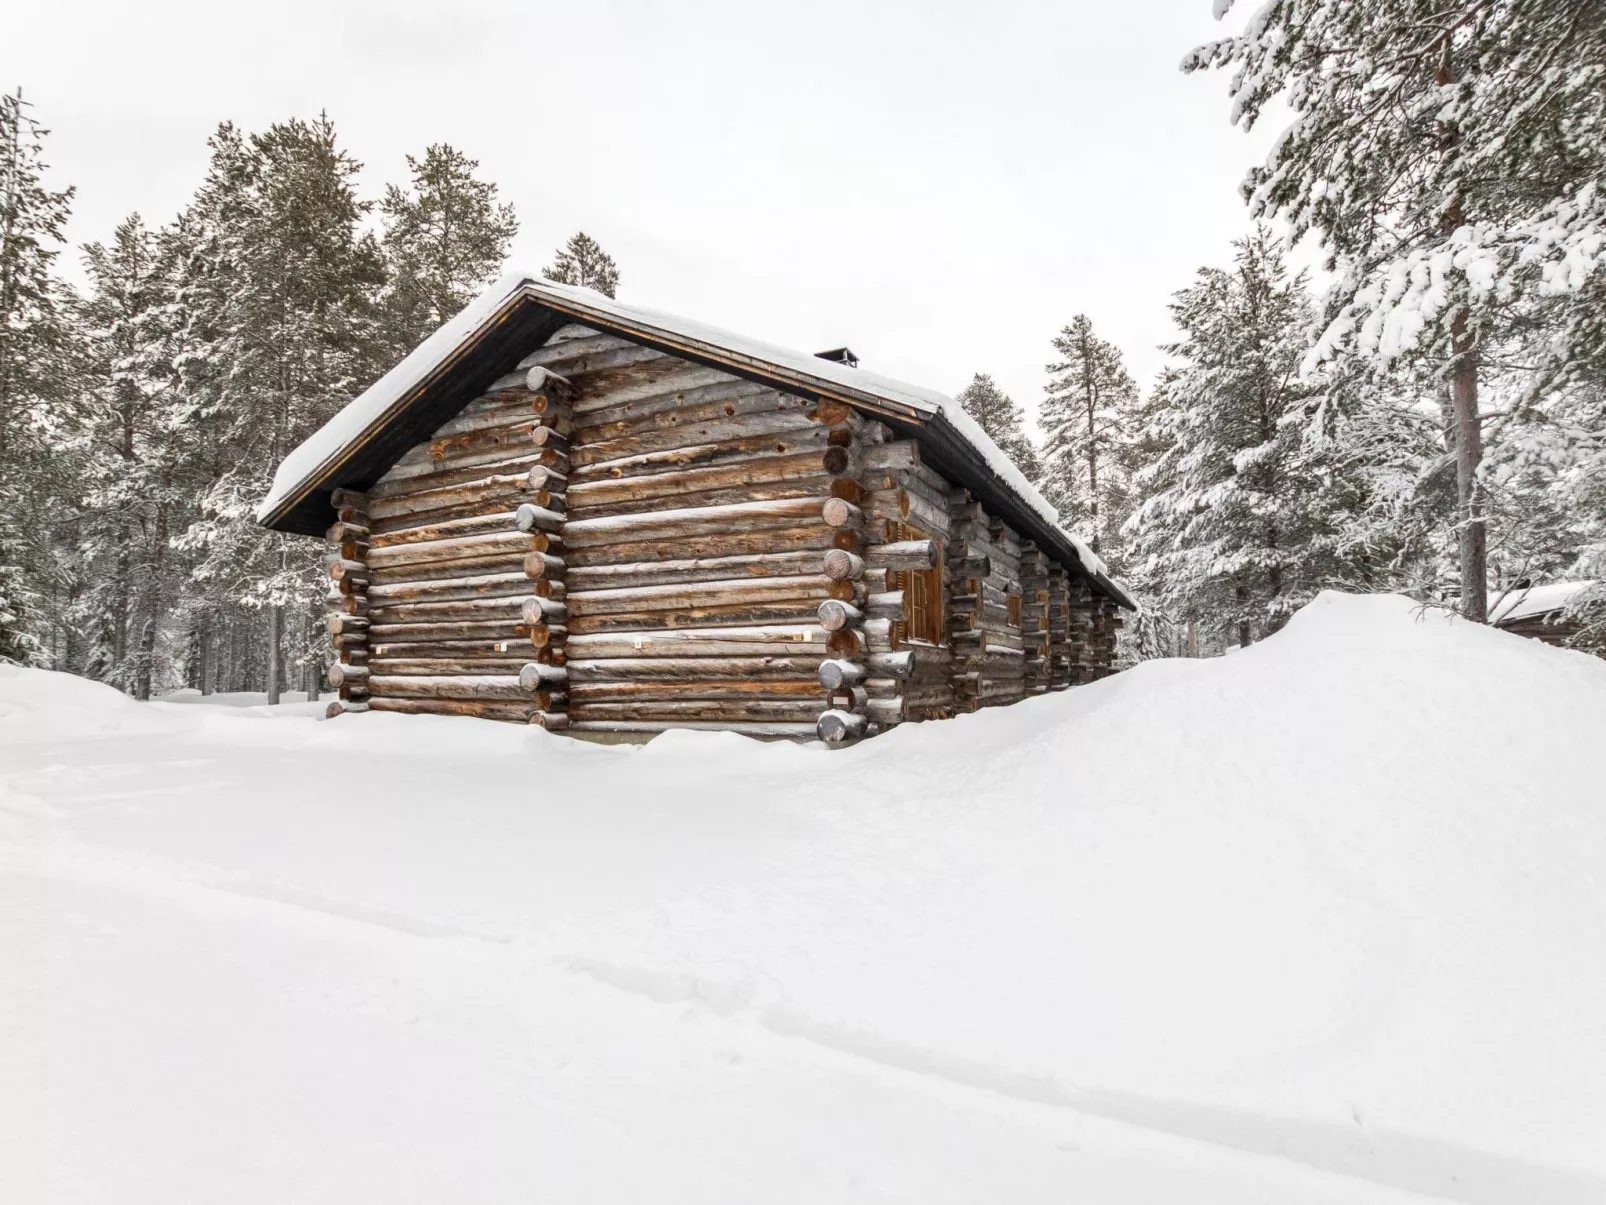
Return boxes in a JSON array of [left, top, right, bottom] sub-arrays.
[[379, 143, 519, 358]]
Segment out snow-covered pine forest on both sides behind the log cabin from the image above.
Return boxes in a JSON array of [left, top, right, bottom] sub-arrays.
[[0, 0, 1606, 701]]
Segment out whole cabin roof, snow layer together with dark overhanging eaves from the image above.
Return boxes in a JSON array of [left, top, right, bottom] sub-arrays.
[[257, 276, 1134, 607]]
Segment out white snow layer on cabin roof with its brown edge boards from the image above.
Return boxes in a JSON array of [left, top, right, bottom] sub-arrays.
[[257, 270, 1135, 607]]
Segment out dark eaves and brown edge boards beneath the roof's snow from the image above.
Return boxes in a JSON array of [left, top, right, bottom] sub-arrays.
[[263, 291, 1137, 611]]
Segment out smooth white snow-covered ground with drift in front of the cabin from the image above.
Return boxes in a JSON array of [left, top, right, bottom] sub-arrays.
[[0, 594, 1606, 1205]]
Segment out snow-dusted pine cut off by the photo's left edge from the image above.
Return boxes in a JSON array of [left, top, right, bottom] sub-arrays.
[[0, 88, 72, 664]]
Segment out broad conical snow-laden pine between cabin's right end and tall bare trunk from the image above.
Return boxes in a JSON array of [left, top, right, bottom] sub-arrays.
[[1126, 228, 1328, 646]]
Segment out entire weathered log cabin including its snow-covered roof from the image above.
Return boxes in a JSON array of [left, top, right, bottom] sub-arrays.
[[257, 272, 1134, 744]]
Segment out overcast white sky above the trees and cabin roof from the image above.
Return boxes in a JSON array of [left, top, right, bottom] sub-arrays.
[[0, 0, 1274, 433]]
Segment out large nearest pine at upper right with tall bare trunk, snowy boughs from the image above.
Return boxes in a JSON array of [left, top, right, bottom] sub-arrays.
[[1184, 0, 1606, 620]]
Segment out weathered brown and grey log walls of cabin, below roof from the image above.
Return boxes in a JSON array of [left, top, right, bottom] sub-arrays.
[[329, 326, 1118, 742]]
